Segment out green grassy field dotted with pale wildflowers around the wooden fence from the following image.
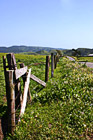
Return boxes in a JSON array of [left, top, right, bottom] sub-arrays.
[[0, 54, 93, 140]]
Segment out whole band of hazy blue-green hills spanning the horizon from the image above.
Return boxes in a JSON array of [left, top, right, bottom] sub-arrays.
[[0, 45, 93, 56]]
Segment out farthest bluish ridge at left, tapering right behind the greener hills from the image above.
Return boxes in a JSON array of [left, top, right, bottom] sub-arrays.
[[0, 45, 63, 53]]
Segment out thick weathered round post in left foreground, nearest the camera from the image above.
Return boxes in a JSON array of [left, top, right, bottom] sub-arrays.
[[6, 70, 15, 134]]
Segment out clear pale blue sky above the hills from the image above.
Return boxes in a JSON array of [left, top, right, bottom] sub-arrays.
[[0, 0, 93, 49]]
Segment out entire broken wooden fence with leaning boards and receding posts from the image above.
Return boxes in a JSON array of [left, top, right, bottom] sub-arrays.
[[3, 53, 59, 134]]
